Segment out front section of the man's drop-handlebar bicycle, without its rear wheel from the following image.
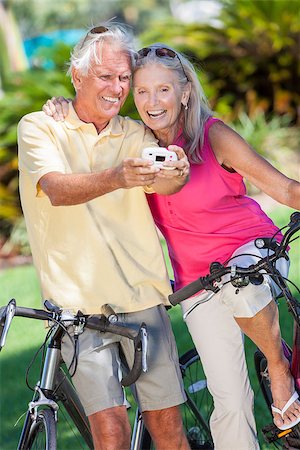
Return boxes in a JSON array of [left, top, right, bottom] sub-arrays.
[[0, 299, 148, 450]]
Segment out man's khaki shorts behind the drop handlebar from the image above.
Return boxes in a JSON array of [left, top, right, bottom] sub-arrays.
[[62, 305, 186, 416]]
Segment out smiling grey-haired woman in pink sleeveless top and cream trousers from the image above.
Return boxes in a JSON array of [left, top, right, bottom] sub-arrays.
[[43, 43, 300, 450]]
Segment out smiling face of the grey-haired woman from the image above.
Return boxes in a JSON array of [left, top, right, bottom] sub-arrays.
[[133, 64, 184, 134]]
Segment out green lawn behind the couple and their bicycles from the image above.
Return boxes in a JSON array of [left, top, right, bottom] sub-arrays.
[[0, 208, 300, 450]]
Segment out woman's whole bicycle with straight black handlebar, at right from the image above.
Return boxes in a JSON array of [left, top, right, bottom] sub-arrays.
[[169, 212, 300, 449]]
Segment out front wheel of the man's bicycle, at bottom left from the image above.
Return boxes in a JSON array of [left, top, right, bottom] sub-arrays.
[[22, 409, 57, 450]]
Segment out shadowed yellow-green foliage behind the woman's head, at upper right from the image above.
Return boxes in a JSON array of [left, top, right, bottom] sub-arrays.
[[140, 0, 300, 121]]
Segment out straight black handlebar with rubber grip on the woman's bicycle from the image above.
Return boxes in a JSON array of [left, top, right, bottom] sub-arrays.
[[169, 211, 300, 306]]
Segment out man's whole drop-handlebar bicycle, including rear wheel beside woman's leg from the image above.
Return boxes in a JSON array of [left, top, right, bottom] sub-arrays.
[[0, 299, 213, 450]]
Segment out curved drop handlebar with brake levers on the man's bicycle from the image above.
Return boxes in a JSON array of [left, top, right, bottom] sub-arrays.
[[0, 299, 148, 386]]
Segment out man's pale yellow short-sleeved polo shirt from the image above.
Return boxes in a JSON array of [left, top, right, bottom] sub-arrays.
[[18, 107, 170, 314]]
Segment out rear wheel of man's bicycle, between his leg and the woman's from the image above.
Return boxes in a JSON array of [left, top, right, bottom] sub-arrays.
[[179, 348, 214, 450]]
